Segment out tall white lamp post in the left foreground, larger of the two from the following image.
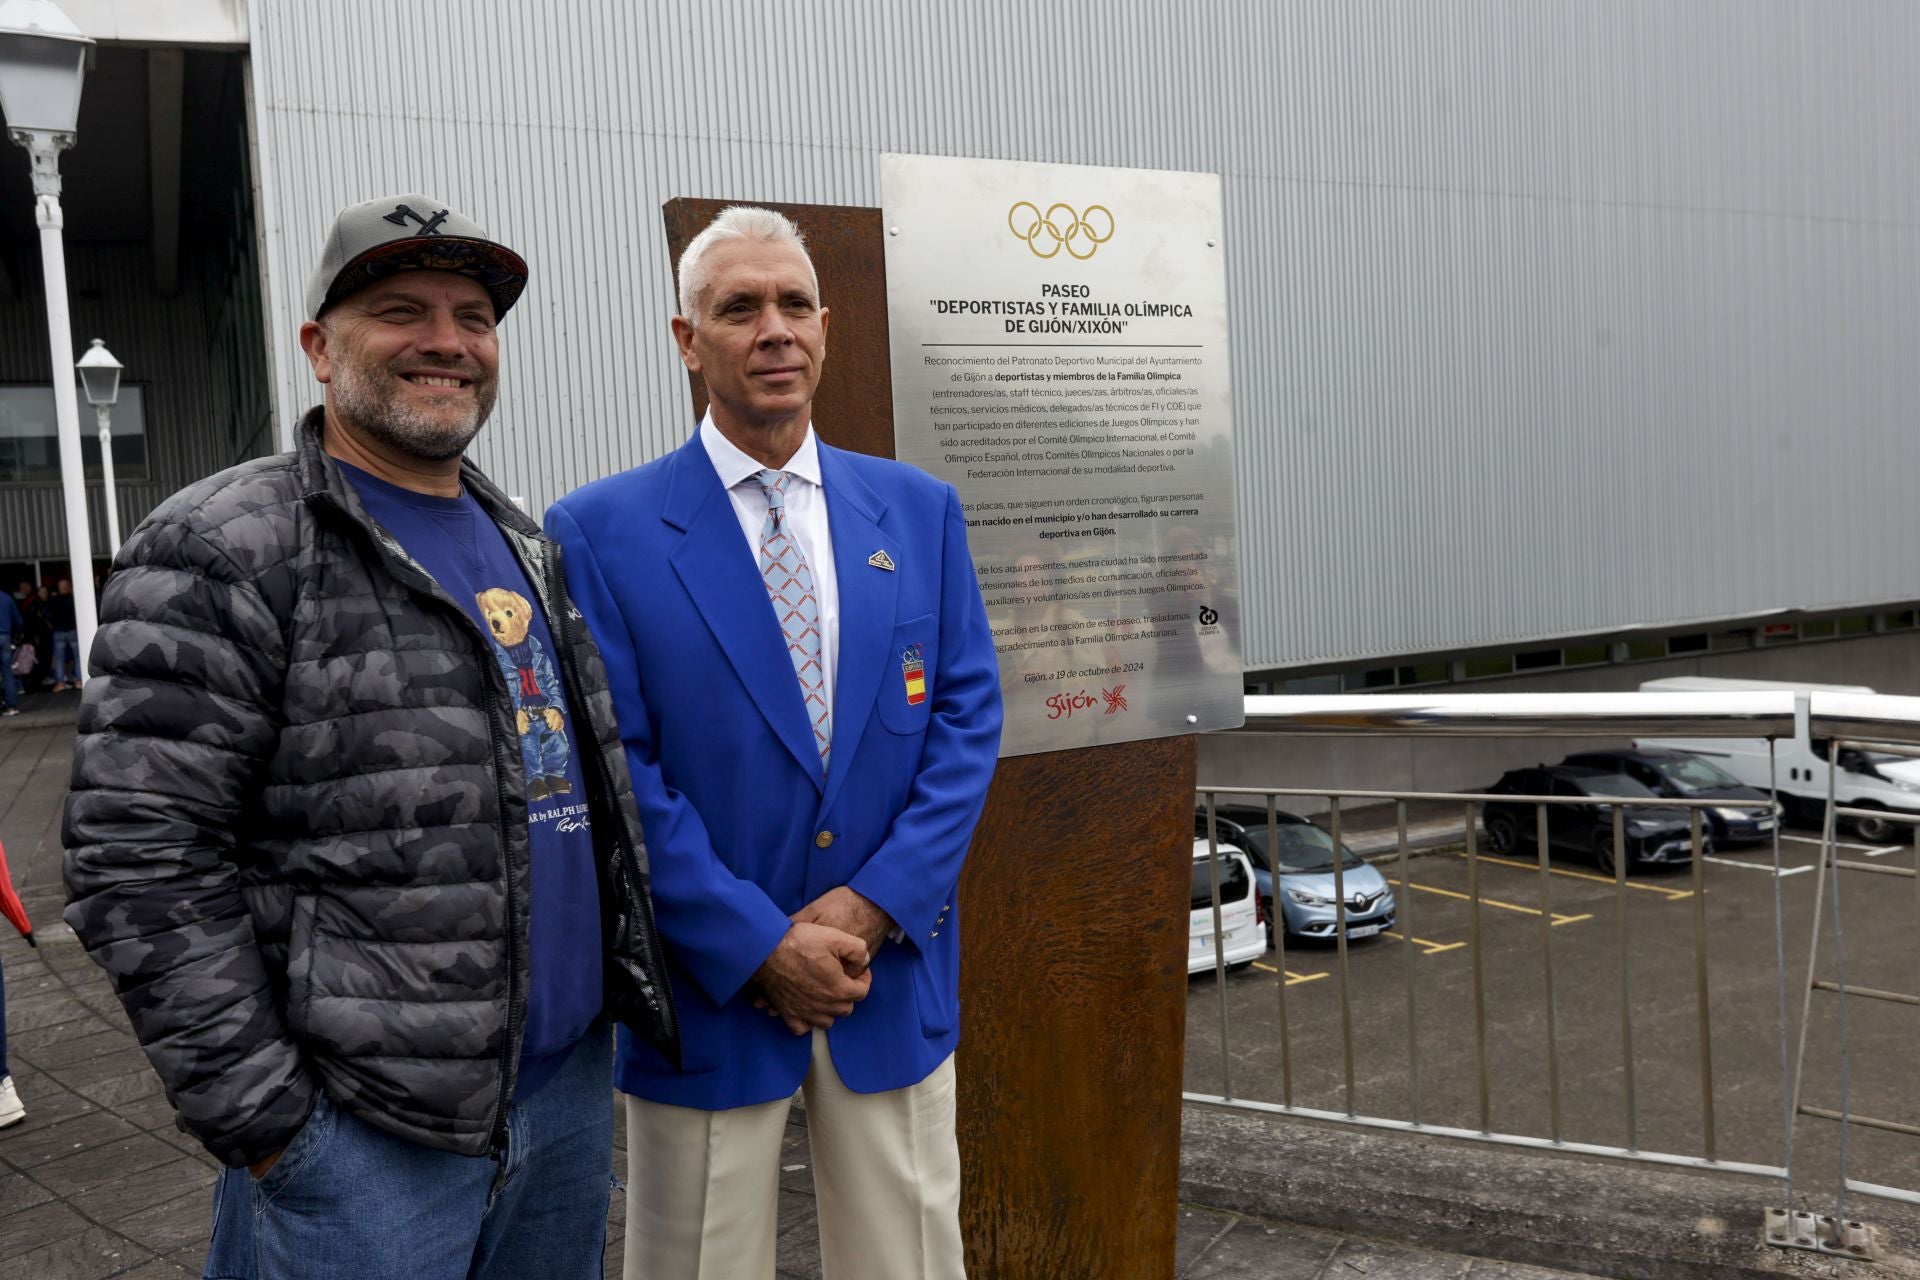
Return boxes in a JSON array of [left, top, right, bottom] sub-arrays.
[[0, 0, 96, 676]]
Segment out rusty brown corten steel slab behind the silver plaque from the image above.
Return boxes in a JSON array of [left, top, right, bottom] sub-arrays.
[[664, 200, 1196, 1280]]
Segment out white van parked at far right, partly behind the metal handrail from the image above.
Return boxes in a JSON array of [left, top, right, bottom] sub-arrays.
[[1634, 676, 1920, 844]]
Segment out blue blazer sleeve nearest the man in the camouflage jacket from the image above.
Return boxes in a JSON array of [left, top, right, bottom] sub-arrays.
[[547, 503, 793, 1004]]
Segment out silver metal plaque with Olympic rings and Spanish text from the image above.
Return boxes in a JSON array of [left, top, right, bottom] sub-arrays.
[[879, 155, 1242, 756]]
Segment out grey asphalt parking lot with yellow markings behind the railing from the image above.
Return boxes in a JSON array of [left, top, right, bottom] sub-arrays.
[[1187, 829, 1920, 1213]]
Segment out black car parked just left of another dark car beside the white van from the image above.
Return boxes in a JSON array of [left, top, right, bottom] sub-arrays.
[[1480, 764, 1713, 875]]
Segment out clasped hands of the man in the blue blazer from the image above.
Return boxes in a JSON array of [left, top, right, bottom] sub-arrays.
[[753, 885, 893, 1036]]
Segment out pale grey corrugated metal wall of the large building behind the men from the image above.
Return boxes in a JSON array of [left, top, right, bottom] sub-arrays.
[[253, 0, 1920, 666]]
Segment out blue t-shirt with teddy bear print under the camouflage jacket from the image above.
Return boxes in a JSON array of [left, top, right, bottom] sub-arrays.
[[340, 462, 601, 1098]]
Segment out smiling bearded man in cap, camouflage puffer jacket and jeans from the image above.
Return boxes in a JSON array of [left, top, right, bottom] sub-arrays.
[[65, 196, 678, 1278]]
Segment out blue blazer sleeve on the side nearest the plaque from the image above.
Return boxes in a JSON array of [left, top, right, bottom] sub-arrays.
[[849, 486, 1000, 950]]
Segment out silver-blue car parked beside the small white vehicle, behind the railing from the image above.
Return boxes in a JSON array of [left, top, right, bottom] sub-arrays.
[[1194, 804, 1394, 942]]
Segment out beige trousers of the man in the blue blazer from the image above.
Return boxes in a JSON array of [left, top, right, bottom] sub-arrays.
[[626, 1031, 966, 1280]]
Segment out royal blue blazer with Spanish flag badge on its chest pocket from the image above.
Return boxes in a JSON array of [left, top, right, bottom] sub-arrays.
[[547, 434, 1000, 1111]]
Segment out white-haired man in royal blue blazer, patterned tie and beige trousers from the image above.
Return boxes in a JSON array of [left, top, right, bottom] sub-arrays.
[[547, 207, 1000, 1280]]
